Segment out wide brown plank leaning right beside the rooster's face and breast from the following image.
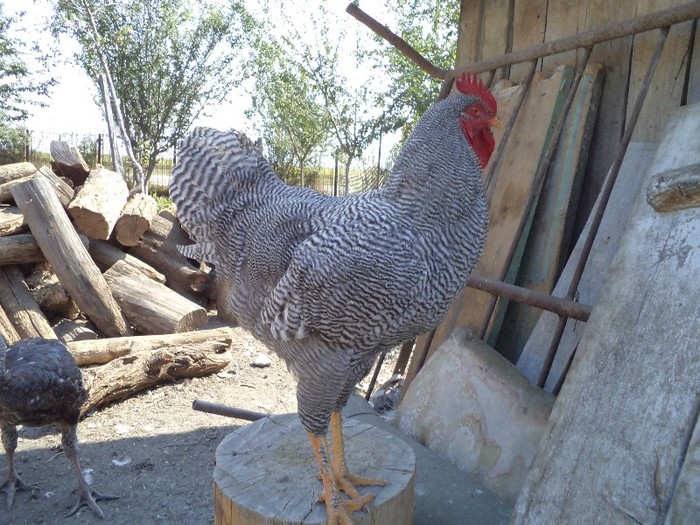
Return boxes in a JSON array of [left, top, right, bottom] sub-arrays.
[[407, 68, 572, 382]]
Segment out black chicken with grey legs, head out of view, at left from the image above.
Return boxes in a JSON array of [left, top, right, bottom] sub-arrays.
[[0, 335, 117, 518]]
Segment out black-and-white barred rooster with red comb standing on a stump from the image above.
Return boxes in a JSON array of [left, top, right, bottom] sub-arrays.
[[170, 74, 500, 524]]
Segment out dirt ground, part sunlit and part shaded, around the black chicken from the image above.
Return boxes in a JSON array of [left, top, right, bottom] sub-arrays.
[[0, 329, 400, 525]]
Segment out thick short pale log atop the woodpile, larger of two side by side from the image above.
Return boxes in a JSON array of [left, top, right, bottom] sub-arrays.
[[68, 166, 129, 240]]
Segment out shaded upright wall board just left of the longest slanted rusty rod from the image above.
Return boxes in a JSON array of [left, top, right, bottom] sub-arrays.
[[575, 0, 637, 246]]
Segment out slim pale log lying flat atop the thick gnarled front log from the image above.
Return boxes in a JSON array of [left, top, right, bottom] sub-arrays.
[[66, 328, 237, 366]]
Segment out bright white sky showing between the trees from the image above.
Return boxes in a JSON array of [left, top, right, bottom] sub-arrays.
[[4, 0, 396, 146]]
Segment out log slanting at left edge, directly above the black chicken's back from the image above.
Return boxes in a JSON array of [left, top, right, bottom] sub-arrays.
[[0, 266, 56, 339]]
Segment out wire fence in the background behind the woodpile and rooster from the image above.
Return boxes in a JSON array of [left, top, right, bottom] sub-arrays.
[[0, 128, 388, 195]]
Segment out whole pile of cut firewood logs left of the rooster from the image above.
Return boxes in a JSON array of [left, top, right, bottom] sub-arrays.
[[0, 150, 232, 412]]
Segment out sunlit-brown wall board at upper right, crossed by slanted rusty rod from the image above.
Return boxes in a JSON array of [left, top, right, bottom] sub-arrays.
[[627, 0, 692, 142]]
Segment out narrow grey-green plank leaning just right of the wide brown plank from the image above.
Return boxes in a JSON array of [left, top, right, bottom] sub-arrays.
[[489, 64, 603, 362]]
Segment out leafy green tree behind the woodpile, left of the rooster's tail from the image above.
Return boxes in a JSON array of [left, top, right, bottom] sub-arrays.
[[53, 0, 250, 185]]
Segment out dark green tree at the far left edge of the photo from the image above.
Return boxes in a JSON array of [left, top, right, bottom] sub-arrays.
[[0, 2, 56, 123]]
